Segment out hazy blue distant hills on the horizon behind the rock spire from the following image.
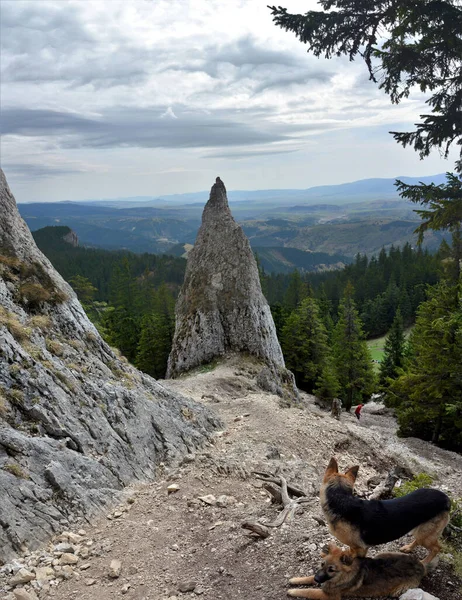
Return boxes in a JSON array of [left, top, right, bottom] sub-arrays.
[[18, 175, 445, 260]]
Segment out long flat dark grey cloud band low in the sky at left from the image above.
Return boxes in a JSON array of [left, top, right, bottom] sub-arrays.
[[3, 107, 288, 148]]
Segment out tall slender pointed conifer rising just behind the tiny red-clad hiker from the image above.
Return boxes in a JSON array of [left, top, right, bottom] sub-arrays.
[[334, 284, 375, 411]]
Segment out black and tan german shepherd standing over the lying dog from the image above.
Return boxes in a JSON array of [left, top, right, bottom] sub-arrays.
[[320, 458, 450, 564]]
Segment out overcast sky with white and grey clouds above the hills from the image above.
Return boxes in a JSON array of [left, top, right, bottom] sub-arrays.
[[0, 0, 453, 201]]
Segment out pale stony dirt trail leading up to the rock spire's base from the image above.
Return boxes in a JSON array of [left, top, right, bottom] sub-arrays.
[[3, 363, 462, 600]]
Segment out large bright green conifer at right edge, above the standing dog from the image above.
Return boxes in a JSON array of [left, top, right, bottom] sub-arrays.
[[386, 281, 462, 451]]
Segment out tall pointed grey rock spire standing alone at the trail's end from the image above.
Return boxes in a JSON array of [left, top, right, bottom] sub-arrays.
[[167, 177, 284, 377]]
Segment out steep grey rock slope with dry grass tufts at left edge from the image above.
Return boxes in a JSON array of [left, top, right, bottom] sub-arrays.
[[0, 171, 221, 563]]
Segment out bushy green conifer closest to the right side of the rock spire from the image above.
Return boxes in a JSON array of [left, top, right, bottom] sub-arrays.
[[281, 298, 329, 392]]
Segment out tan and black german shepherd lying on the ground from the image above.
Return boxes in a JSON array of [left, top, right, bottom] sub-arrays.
[[288, 544, 425, 600]]
